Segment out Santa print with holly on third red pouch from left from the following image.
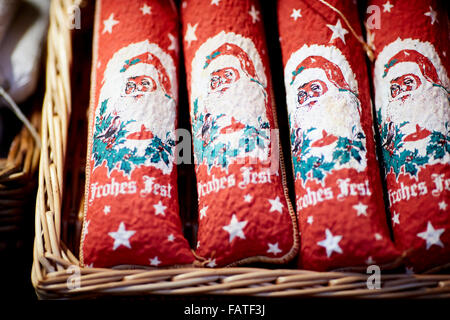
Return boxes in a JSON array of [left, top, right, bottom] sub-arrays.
[[285, 45, 367, 182]]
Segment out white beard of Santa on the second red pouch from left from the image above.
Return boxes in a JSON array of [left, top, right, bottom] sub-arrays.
[[203, 78, 267, 128]]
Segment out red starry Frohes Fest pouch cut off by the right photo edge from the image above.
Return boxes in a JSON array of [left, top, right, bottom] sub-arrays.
[[367, 0, 450, 272]]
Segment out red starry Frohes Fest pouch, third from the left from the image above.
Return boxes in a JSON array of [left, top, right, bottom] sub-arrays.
[[278, 0, 398, 270]]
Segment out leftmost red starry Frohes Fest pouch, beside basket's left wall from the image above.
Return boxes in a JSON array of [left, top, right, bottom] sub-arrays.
[[80, 0, 194, 267]]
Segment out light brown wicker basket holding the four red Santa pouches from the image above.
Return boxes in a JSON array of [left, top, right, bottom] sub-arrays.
[[31, 0, 450, 299]]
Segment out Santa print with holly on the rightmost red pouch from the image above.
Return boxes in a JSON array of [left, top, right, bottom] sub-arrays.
[[374, 39, 450, 176]]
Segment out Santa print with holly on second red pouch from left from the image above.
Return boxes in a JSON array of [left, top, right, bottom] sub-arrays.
[[191, 32, 270, 168]]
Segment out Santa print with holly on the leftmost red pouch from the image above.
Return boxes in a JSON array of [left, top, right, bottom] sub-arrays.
[[92, 41, 176, 174]]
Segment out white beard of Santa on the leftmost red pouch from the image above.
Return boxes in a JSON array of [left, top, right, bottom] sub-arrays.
[[107, 91, 176, 156]]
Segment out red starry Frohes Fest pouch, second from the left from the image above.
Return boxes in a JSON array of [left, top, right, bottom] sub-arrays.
[[181, 0, 297, 267]]
